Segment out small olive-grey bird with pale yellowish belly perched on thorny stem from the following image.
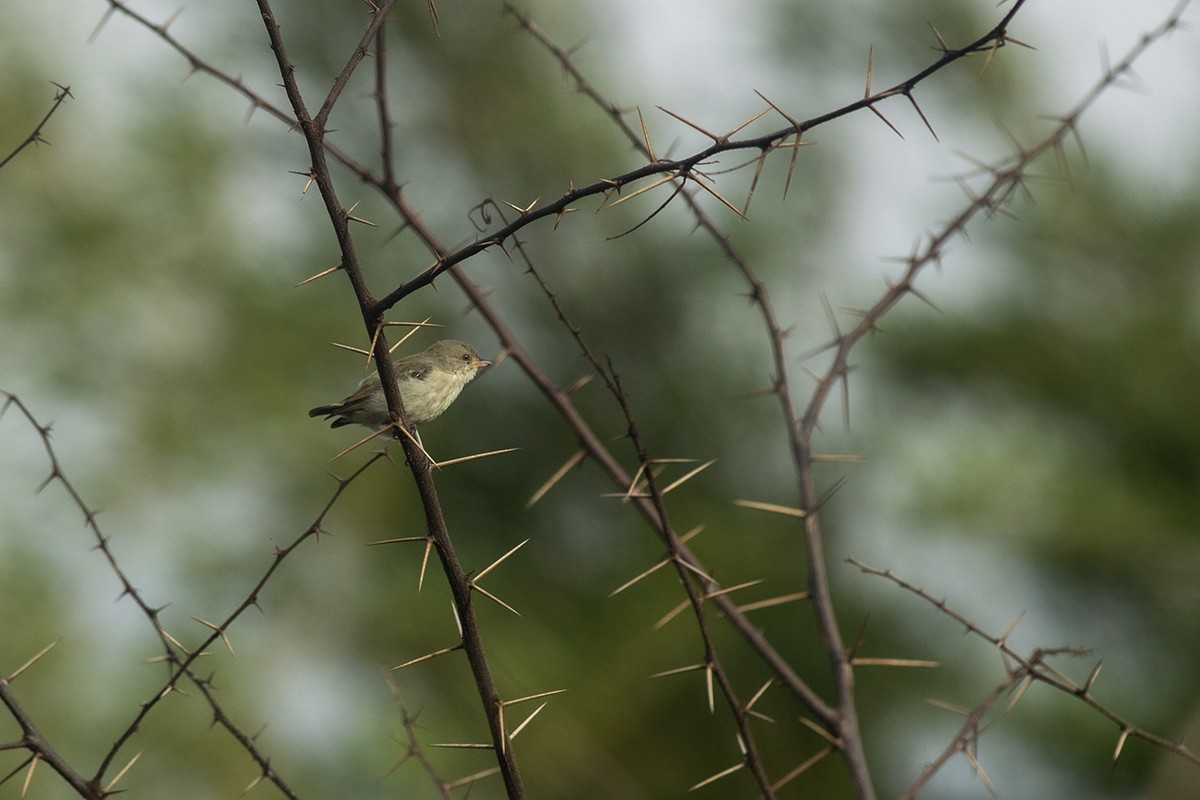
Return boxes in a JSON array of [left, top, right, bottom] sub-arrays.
[[308, 339, 492, 428]]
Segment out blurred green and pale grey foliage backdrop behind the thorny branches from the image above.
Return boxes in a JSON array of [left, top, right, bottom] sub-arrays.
[[0, 0, 1200, 800]]
